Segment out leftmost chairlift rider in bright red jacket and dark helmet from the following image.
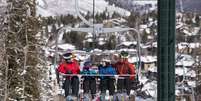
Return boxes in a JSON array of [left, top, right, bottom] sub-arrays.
[[58, 53, 80, 97]]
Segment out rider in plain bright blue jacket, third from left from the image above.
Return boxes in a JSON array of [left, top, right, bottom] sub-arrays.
[[99, 60, 117, 96]]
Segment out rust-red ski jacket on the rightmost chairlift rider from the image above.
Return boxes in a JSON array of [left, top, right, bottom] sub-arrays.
[[114, 61, 135, 80]]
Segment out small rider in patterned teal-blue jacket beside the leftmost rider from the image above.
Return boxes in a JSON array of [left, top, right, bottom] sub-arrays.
[[82, 61, 97, 99]]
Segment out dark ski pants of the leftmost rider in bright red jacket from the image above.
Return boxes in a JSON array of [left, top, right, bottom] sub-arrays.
[[63, 76, 79, 97]]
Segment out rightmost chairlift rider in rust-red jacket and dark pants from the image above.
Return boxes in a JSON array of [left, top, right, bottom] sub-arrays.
[[114, 51, 135, 95]]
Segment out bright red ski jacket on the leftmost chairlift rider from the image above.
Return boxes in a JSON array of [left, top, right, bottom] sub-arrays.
[[58, 62, 80, 74]]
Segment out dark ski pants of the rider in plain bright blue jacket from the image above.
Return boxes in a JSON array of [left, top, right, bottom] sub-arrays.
[[100, 77, 115, 95]]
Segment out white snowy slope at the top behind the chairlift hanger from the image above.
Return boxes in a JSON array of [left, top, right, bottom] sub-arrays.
[[37, 0, 130, 16]]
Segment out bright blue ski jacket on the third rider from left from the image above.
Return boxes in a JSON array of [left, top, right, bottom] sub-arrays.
[[99, 65, 117, 79]]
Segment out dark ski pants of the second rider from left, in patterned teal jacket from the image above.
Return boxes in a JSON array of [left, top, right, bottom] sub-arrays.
[[83, 77, 96, 95]]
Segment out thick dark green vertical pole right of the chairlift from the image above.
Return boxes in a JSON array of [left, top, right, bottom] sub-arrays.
[[157, 0, 176, 101]]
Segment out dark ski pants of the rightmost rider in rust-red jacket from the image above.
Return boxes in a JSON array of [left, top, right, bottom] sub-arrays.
[[117, 77, 131, 95]]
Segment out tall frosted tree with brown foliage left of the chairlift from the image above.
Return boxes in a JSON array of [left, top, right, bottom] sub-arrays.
[[4, 0, 43, 101]]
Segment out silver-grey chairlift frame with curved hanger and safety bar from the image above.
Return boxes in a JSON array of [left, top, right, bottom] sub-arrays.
[[55, 0, 141, 98]]
